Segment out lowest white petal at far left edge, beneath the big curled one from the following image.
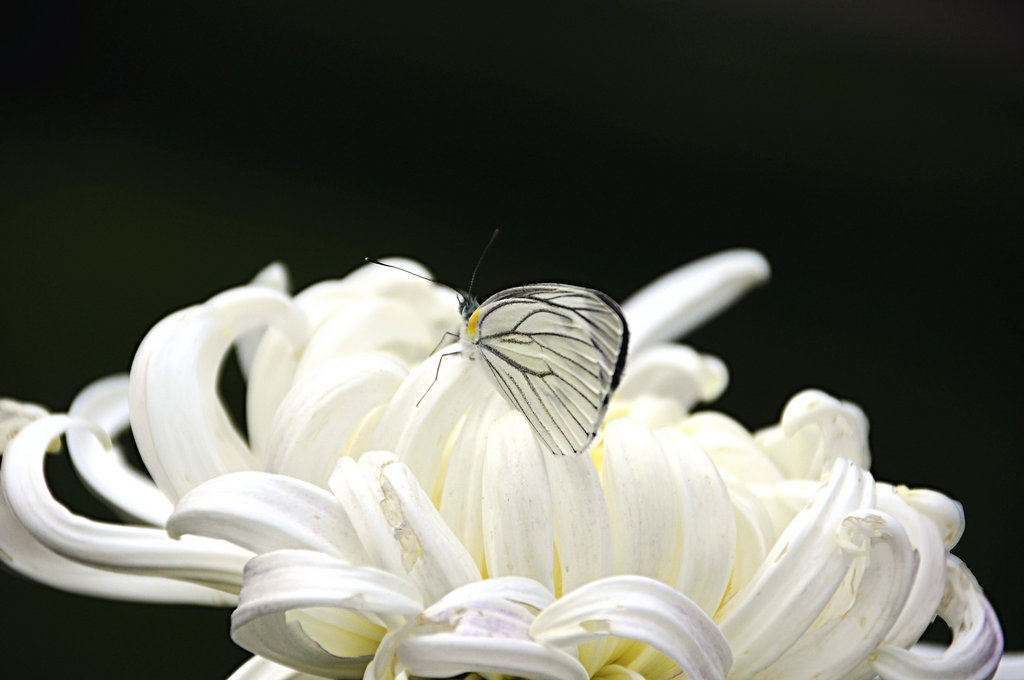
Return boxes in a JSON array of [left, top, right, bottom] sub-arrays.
[[0, 475, 236, 606]]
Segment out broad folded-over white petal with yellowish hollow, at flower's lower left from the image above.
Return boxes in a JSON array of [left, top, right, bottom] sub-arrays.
[[231, 550, 421, 678]]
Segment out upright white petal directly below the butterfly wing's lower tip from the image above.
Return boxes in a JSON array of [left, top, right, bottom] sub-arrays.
[[544, 438, 615, 593]]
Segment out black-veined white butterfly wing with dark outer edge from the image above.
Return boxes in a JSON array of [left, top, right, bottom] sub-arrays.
[[468, 284, 629, 455]]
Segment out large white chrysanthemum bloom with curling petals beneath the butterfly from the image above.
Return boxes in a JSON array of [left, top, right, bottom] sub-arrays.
[[0, 251, 1002, 680]]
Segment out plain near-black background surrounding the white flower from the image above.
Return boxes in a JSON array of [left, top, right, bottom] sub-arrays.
[[0, 0, 1024, 678]]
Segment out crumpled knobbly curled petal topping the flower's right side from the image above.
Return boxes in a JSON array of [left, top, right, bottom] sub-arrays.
[[756, 389, 871, 479]]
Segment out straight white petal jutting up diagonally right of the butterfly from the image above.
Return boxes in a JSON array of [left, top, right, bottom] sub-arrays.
[[623, 250, 769, 351]]
